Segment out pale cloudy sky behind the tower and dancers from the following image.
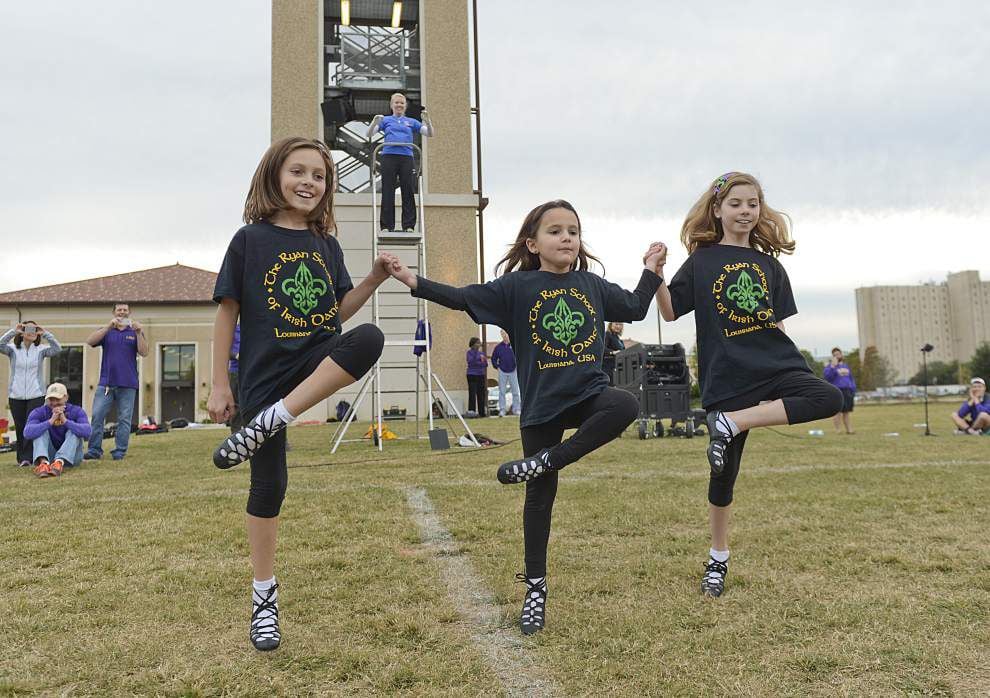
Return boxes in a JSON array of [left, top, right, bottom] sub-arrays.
[[0, 0, 990, 352]]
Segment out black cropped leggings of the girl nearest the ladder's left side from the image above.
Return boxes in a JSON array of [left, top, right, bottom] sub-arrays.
[[241, 325, 385, 519]]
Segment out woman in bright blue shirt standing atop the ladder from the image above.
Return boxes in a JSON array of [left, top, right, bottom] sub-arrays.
[[368, 92, 434, 233]]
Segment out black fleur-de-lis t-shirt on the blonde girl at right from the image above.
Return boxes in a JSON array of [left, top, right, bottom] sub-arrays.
[[668, 245, 811, 409]]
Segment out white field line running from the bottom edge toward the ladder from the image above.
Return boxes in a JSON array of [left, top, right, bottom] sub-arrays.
[[404, 487, 561, 696]]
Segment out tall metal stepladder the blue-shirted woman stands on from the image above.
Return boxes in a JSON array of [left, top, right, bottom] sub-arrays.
[[330, 142, 481, 453]]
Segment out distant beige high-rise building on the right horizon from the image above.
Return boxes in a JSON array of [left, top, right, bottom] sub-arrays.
[[856, 271, 990, 381]]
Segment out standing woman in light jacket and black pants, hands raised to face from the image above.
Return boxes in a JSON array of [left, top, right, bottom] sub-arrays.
[[0, 320, 62, 468]]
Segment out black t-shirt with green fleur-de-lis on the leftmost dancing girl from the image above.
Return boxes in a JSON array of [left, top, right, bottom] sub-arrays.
[[213, 223, 354, 409]]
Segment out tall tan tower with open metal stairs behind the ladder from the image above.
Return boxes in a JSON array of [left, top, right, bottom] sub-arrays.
[[271, 0, 481, 420]]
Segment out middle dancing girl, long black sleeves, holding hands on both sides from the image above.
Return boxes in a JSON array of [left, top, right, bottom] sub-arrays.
[[392, 200, 661, 635]]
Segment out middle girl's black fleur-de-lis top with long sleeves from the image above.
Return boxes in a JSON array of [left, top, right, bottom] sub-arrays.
[[413, 270, 660, 427]]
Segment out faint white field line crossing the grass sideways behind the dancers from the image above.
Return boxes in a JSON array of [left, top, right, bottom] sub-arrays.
[[0, 459, 984, 511]]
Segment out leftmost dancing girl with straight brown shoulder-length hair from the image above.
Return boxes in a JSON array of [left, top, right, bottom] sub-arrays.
[[208, 138, 394, 650]]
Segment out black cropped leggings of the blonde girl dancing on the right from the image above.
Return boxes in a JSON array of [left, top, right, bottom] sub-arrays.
[[707, 371, 842, 507]]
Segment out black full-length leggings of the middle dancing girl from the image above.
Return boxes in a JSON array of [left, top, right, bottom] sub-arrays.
[[520, 388, 639, 577]]
